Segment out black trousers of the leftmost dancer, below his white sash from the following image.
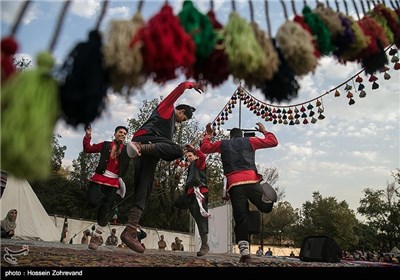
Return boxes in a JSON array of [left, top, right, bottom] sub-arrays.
[[86, 182, 118, 227]]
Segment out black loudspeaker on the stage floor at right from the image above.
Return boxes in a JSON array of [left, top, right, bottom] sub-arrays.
[[300, 236, 342, 263]]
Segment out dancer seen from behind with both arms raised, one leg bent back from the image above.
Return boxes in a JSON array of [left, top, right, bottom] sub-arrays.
[[200, 123, 278, 262]]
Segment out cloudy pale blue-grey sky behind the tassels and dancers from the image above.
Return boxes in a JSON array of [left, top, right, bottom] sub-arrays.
[[1, 0, 400, 219]]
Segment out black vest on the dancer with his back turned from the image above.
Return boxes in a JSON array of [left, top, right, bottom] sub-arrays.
[[221, 137, 257, 174]]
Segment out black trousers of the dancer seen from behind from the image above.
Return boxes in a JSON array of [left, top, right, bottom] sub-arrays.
[[229, 183, 273, 243]]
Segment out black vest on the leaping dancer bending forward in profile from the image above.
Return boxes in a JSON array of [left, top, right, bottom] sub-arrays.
[[140, 109, 175, 140]]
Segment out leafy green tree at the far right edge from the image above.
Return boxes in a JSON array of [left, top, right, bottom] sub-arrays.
[[357, 169, 400, 251]]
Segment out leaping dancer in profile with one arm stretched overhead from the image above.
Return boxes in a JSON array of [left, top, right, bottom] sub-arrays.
[[121, 82, 203, 253]]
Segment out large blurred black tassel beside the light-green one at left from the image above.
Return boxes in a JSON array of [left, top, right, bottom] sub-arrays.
[[59, 30, 108, 127]]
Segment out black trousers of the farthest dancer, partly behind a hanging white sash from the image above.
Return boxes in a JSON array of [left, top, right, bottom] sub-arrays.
[[174, 192, 208, 236]]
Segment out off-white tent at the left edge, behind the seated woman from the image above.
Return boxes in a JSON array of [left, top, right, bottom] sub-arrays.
[[0, 174, 61, 242]]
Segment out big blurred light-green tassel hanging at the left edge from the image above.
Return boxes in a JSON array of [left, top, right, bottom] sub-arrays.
[[1, 52, 59, 180]]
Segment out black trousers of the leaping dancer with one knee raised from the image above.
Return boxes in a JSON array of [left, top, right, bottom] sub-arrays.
[[132, 136, 183, 211]]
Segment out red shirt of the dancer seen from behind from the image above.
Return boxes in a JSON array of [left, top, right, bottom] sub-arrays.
[[200, 132, 278, 190]]
